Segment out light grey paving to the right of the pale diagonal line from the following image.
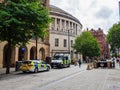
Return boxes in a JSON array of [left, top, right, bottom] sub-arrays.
[[37, 63, 120, 90]]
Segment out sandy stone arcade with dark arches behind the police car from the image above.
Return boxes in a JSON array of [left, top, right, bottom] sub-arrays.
[[0, 40, 49, 68]]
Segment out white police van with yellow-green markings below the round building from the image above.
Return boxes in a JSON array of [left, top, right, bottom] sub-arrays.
[[51, 53, 71, 68]]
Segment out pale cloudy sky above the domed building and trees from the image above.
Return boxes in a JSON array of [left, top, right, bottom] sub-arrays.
[[50, 0, 120, 34]]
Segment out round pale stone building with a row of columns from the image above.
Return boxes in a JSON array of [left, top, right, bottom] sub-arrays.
[[49, 5, 82, 59]]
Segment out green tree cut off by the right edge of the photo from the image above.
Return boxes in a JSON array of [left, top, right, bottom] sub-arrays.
[[107, 23, 120, 54]]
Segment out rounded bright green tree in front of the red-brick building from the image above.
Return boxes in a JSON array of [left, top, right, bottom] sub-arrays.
[[73, 31, 100, 61]]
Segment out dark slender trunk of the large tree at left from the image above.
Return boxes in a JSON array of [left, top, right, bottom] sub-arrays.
[[6, 42, 12, 74]]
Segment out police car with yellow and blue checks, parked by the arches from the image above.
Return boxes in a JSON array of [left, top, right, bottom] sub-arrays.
[[20, 60, 51, 73]]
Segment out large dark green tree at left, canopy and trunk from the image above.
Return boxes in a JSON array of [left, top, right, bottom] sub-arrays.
[[0, 0, 51, 74]]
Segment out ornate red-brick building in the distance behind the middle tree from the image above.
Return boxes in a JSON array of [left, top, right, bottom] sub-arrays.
[[90, 28, 110, 58]]
